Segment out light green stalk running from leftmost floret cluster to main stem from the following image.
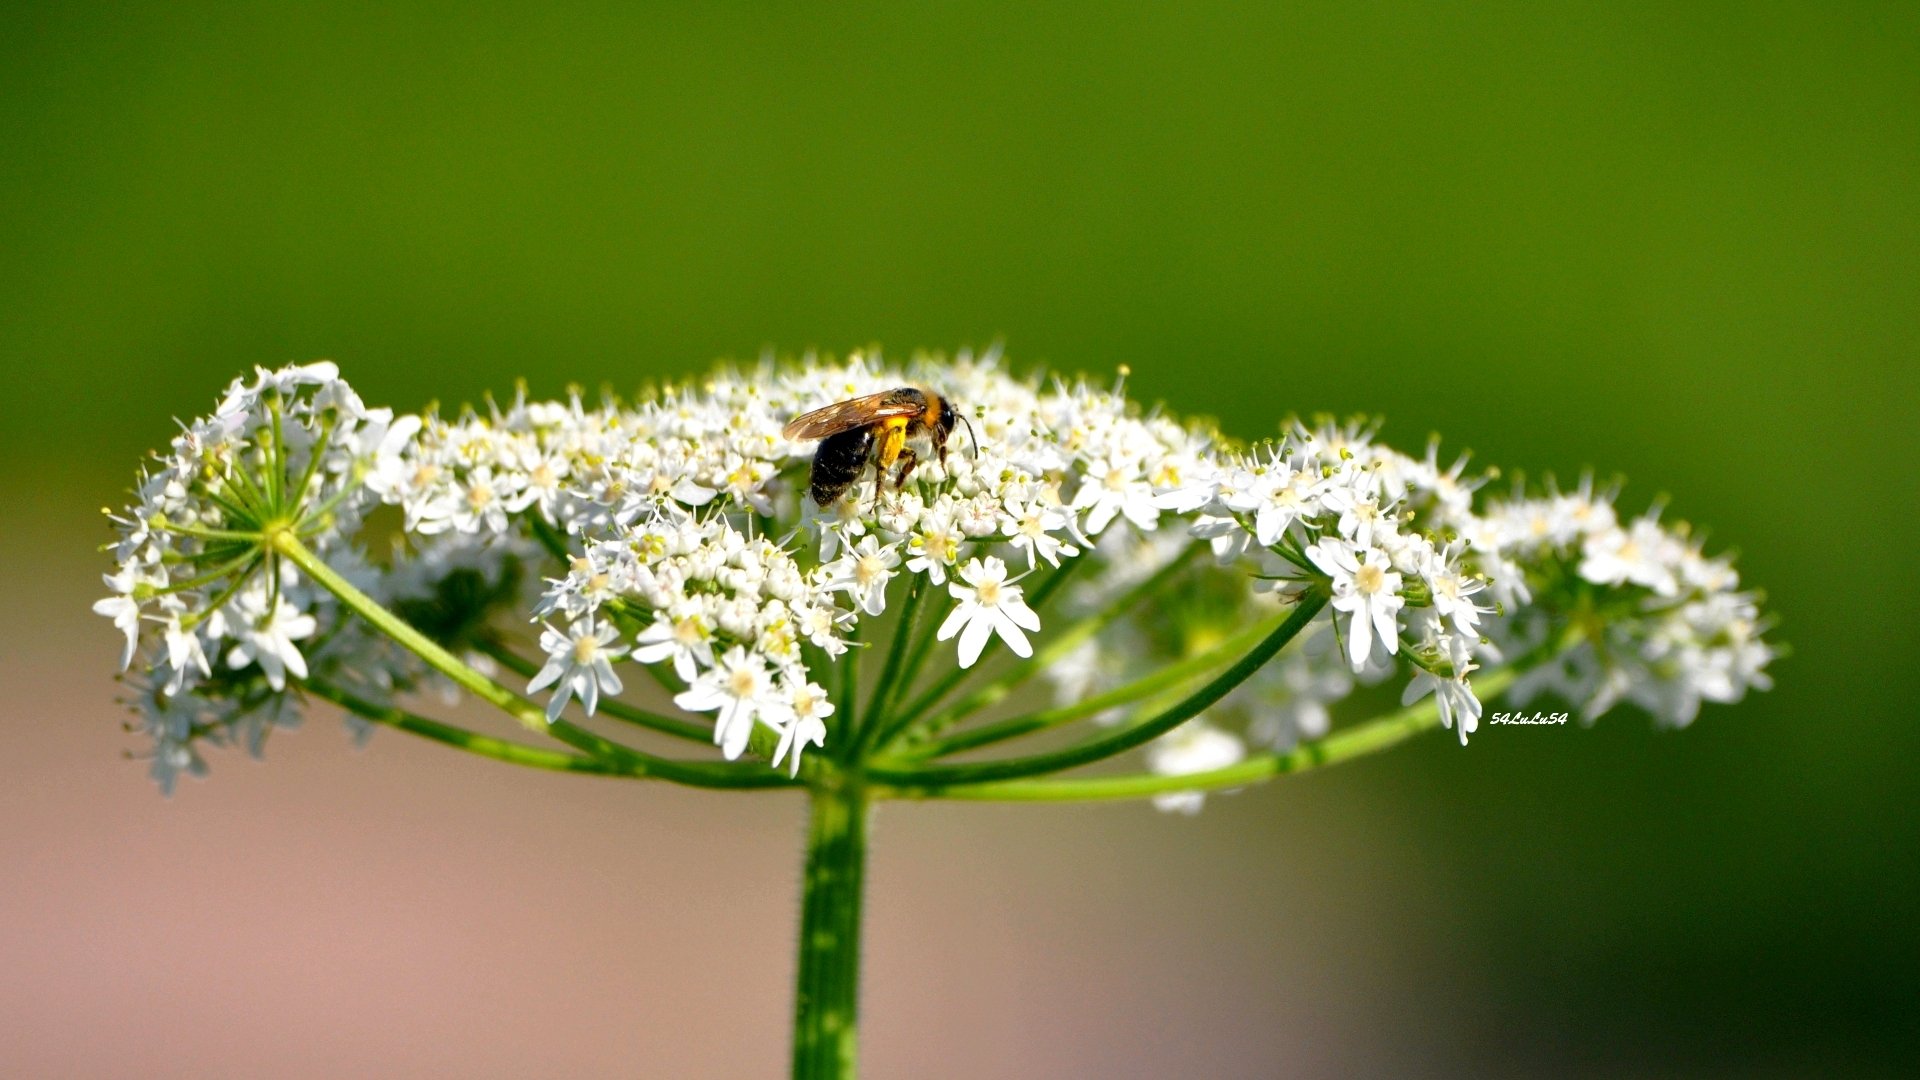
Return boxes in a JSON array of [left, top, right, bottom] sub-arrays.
[[269, 528, 793, 788]]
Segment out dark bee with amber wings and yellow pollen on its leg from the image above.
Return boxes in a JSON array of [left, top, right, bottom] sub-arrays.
[[780, 386, 979, 505]]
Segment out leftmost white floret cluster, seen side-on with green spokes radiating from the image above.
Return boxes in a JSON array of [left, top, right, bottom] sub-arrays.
[[94, 363, 420, 788]]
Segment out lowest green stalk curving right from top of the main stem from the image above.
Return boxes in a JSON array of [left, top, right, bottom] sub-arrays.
[[885, 667, 1519, 803]]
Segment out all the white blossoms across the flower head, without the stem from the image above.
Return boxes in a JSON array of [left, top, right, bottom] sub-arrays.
[[96, 354, 1772, 795]]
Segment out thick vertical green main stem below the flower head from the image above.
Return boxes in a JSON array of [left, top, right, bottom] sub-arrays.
[[793, 780, 872, 1080]]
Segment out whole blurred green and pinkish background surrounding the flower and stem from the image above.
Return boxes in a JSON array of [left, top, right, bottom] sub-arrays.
[[0, 4, 1920, 1076]]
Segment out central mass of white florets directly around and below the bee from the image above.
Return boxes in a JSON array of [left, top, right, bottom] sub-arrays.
[[369, 356, 1208, 767]]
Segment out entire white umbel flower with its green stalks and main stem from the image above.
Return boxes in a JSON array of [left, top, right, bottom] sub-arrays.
[[96, 354, 1778, 1078]]
